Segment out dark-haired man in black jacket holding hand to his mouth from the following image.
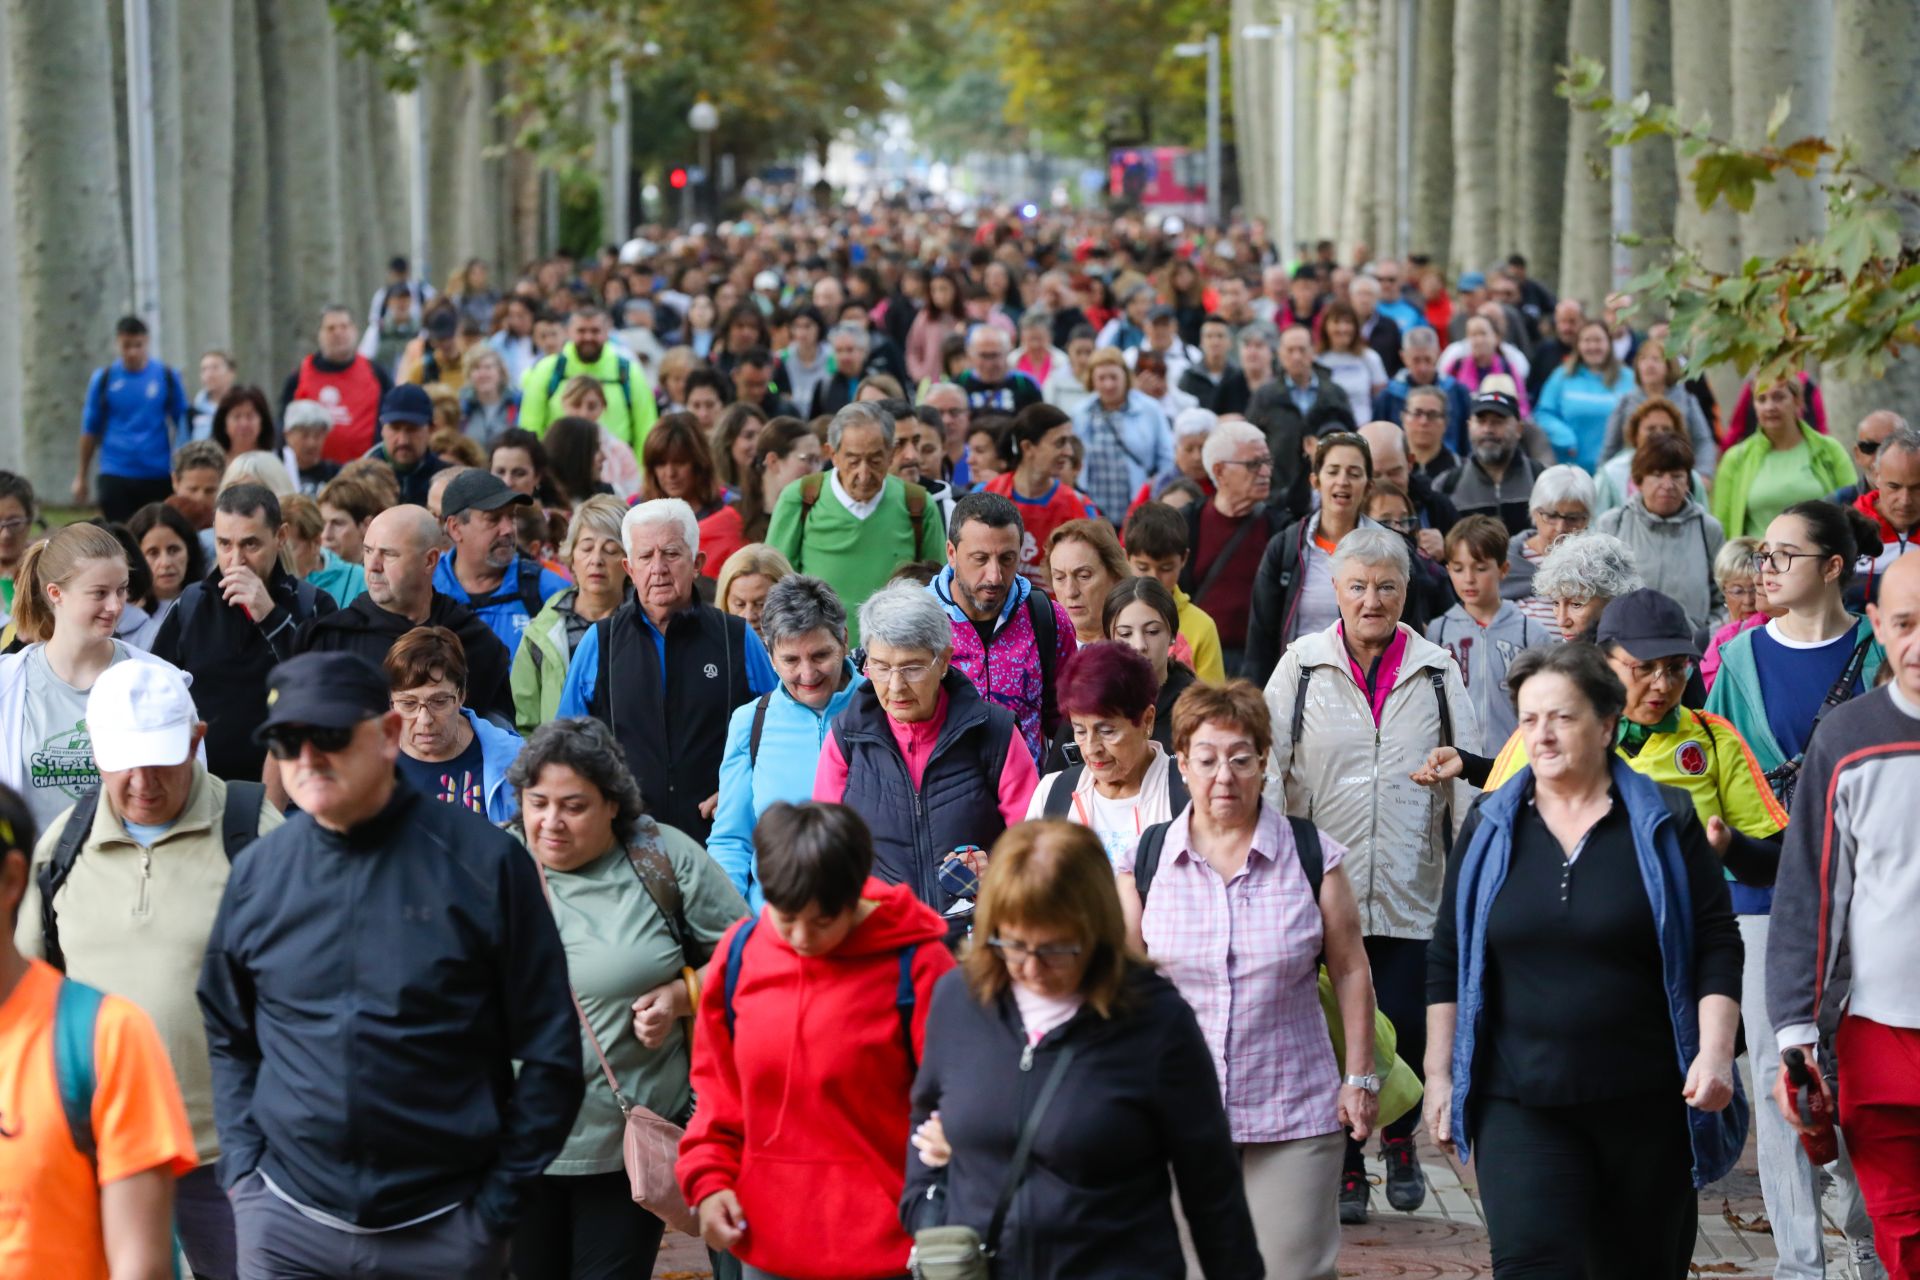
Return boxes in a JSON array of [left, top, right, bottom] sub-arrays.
[[154, 484, 338, 783]]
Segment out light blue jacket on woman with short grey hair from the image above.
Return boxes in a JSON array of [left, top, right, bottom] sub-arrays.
[[707, 658, 866, 915]]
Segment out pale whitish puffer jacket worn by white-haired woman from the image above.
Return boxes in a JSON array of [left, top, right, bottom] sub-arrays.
[[1267, 624, 1480, 938]]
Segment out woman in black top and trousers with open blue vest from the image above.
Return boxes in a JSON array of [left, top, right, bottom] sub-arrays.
[[1425, 643, 1747, 1280]]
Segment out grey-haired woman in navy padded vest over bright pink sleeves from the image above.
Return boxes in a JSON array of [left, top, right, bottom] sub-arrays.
[[814, 581, 1039, 936]]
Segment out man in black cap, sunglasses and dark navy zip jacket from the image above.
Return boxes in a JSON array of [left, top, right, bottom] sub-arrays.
[[200, 654, 584, 1276]]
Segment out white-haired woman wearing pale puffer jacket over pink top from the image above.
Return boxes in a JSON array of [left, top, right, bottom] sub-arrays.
[[1267, 528, 1480, 1222]]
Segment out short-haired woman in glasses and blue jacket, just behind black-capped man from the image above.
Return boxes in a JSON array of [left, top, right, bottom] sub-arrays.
[[382, 628, 520, 823]]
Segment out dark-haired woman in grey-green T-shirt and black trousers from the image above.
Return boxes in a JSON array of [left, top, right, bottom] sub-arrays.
[[509, 720, 747, 1280]]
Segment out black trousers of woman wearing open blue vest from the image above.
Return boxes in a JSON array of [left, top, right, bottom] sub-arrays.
[[1473, 1092, 1699, 1280]]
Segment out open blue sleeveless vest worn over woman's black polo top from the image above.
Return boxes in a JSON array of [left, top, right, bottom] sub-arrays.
[[1453, 756, 1747, 1186]]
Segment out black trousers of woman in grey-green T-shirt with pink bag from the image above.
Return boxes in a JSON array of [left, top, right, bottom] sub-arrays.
[[513, 1169, 666, 1280]]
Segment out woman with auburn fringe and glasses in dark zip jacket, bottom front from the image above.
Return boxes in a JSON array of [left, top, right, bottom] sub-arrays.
[[900, 821, 1267, 1280]]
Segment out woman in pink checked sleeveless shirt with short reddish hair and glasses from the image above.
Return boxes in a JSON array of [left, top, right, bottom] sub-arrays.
[[1119, 681, 1380, 1280]]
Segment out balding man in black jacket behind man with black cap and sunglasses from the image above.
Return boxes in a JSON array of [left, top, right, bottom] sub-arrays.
[[294, 507, 513, 723]]
